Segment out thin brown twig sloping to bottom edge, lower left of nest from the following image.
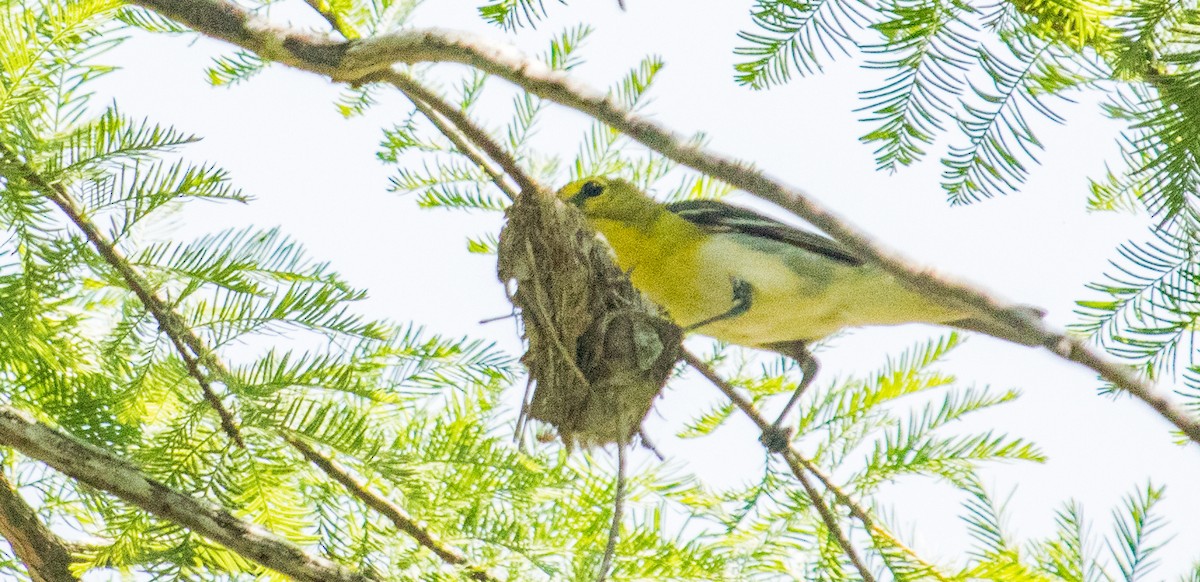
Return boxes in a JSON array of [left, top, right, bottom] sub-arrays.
[[287, 437, 498, 582]]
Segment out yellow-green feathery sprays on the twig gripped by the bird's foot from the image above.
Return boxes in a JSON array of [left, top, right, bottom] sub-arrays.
[[684, 334, 1045, 580]]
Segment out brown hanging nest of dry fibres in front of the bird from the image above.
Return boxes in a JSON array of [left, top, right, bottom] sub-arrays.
[[498, 192, 683, 446]]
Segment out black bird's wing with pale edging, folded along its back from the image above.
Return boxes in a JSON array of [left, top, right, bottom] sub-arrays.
[[666, 200, 863, 266]]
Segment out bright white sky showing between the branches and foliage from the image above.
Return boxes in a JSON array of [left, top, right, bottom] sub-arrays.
[[88, 0, 1200, 578]]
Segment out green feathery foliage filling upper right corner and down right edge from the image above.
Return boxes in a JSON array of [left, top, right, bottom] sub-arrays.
[[715, 0, 1200, 396]]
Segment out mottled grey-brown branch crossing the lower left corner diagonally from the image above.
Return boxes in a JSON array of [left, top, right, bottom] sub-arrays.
[[0, 407, 378, 582]]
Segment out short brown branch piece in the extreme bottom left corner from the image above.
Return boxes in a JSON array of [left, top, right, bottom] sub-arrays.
[[0, 473, 79, 582]]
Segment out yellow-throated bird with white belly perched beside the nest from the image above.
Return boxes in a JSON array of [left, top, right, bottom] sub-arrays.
[[557, 176, 1044, 452]]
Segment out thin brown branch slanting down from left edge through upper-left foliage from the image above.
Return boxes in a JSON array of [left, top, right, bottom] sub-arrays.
[[0, 143, 246, 448]]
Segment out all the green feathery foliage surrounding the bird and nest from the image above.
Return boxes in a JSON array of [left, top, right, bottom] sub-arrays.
[[7, 0, 1200, 581]]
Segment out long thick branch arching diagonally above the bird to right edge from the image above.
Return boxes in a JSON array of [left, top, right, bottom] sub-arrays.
[[132, 0, 1200, 443]]
